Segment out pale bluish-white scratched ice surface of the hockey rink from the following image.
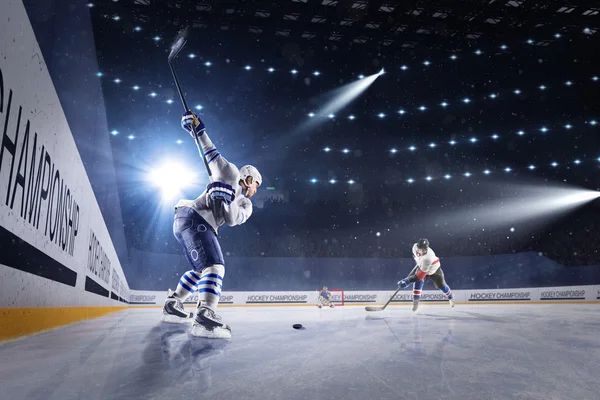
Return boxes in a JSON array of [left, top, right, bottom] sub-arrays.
[[0, 304, 600, 400]]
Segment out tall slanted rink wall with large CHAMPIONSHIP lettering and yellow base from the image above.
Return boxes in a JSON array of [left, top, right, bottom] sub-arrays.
[[0, 0, 129, 340]]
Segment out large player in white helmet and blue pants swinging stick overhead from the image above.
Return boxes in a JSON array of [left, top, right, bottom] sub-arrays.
[[162, 112, 262, 339]]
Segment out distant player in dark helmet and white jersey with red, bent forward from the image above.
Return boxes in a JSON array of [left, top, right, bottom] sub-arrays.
[[398, 239, 455, 311]]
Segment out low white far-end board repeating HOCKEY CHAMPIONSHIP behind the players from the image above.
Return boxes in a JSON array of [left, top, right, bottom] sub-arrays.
[[129, 286, 600, 306]]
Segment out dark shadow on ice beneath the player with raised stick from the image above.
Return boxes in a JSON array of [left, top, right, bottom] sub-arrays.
[[107, 323, 230, 398]]
